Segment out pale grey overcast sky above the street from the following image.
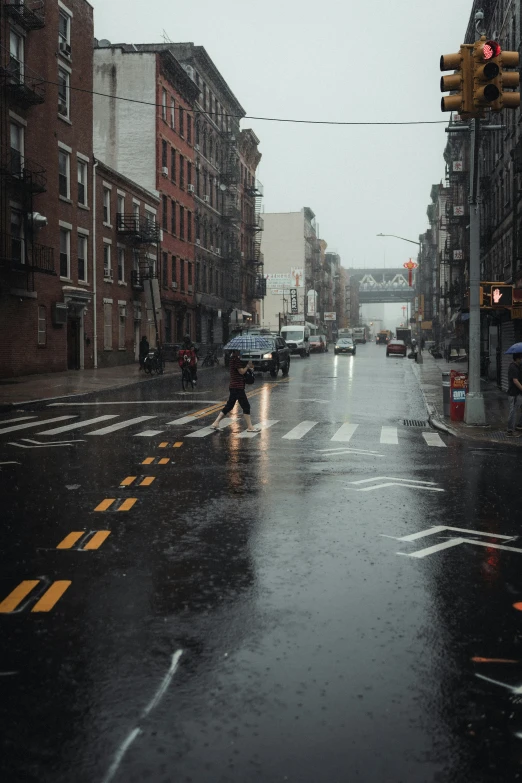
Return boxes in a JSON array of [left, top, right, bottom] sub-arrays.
[[91, 0, 472, 324]]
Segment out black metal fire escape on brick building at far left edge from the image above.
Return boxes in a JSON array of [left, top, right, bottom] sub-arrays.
[[0, 0, 56, 291]]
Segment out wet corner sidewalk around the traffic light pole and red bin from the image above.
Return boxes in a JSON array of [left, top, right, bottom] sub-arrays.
[[412, 350, 512, 446]]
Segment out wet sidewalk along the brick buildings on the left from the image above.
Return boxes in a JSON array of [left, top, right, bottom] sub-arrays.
[[0, 362, 183, 411]]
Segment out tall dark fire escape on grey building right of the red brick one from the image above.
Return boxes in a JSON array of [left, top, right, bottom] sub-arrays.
[[221, 132, 242, 305]]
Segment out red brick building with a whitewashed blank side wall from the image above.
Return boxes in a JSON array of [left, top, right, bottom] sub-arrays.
[[94, 40, 199, 343]]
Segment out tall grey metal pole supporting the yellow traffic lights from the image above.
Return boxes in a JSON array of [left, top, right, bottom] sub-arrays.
[[464, 119, 486, 426]]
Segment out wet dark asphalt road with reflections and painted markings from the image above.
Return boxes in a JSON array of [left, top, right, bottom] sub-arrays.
[[0, 344, 522, 783]]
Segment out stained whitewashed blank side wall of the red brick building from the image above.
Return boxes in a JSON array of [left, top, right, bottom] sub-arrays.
[[94, 49, 158, 196]]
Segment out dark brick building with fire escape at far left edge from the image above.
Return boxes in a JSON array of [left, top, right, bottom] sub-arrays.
[[0, 0, 94, 377]]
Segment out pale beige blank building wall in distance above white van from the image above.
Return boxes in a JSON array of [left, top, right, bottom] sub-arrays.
[[261, 210, 306, 329]]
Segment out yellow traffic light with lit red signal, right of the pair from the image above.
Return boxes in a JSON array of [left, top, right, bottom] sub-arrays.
[[473, 35, 520, 116]]
